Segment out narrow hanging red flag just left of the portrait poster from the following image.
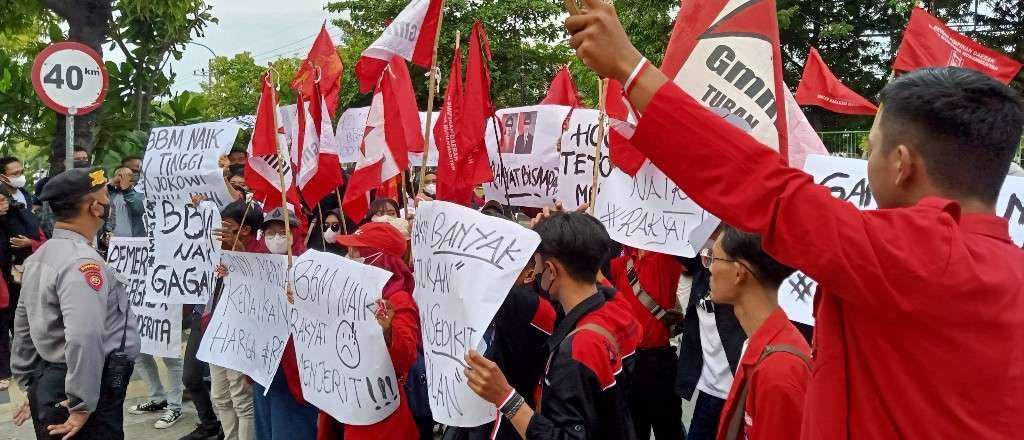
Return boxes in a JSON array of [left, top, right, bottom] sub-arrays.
[[459, 20, 495, 187]]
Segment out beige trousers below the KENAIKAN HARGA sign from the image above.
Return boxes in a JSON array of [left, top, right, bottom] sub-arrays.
[[210, 365, 256, 440]]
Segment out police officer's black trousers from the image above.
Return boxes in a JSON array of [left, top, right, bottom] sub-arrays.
[[29, 362, 131, 440]]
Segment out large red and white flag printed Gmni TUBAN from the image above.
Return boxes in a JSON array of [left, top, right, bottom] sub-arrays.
[[662, 0, 787, 158]]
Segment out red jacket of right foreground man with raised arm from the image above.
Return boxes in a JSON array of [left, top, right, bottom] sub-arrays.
[[632, 83, 1024, 439]]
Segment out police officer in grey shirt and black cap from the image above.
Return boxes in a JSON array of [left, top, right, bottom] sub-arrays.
[[11, 169, 139, 440]]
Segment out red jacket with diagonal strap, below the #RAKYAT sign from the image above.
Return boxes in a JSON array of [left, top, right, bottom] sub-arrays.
[[611, 251, 683, 349]]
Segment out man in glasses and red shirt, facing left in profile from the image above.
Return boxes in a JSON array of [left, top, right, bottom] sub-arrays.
[[700, 226, 811, 440]]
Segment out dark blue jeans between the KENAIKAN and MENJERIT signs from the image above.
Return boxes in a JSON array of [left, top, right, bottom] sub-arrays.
[[253, 368, 318, 440]]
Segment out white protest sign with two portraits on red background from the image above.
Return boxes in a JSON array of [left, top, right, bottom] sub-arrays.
[[483, 105, 569, 208]]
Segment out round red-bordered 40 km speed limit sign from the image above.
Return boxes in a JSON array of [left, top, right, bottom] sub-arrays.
[[32, 41, 108, 115]]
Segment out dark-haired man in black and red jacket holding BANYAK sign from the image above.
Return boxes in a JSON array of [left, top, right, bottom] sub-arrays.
[[466, 212, 640, 440]]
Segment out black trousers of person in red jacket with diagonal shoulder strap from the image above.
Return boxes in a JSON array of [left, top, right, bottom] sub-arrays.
[[629, 346, 686, 440]]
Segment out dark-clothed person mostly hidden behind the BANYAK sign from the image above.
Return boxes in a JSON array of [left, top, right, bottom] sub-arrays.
[[444, 210, 556, 440]]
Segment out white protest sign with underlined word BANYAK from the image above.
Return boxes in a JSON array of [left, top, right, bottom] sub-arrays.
[[413, 202, 541, 427]]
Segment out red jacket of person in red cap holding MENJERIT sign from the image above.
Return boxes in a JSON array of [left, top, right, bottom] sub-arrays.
[[316, 291, 422, 440]]
